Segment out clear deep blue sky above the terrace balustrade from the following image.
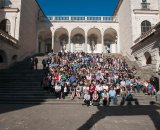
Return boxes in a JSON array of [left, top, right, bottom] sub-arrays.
[[37, 0, 118, 16]]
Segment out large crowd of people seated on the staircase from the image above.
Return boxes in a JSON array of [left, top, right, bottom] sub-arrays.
[[42, 52, 156, 106]]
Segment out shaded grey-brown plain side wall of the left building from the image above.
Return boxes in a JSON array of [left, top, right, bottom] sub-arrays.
[[19, 0, 38, 60]]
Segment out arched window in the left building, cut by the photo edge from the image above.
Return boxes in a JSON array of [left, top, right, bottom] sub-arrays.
[[0, 19, 11, 33]]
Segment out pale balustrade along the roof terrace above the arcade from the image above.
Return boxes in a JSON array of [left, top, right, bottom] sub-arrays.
[[41, 16, 118, 22]]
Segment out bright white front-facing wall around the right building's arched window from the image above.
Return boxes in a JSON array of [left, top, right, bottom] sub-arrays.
[[130, 0, 160, 42]]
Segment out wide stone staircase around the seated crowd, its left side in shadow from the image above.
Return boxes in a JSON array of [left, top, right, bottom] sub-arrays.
[[0, 54, 156, 104]]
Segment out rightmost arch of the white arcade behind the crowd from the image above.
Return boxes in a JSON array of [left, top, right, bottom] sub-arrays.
[[103, 28, 117, 53]]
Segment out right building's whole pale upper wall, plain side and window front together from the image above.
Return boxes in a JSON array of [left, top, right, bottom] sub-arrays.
[[116, 0, 160, 60]]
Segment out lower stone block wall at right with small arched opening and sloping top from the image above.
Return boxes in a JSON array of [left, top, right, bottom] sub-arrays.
[[133, 29, 160, 72]]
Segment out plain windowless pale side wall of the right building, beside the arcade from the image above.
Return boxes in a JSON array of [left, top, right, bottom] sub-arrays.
[[117, 0, 132, 55]]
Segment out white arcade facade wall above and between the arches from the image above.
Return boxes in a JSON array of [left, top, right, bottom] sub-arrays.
[[48, 22, 120, 53]]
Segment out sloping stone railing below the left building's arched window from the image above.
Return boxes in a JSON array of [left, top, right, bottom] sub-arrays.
[[0, 30, 19, 47]]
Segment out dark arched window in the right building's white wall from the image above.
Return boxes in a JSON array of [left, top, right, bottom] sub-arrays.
[[141, 20, 151, 34]]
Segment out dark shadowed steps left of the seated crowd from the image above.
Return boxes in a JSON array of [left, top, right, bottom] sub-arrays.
[[0, 59, 51, 103]]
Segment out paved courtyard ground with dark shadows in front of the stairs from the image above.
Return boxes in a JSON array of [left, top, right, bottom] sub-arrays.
[[0, 104, 160, 130]]
